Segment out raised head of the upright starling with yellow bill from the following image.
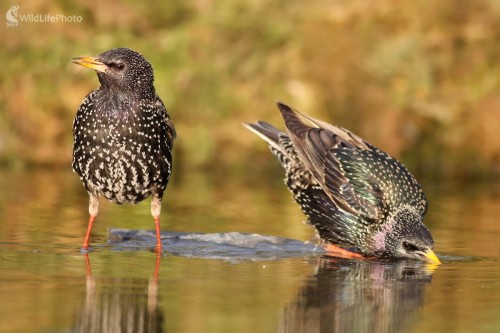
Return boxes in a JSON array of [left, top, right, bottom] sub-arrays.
[[73, 48, 154, 97]]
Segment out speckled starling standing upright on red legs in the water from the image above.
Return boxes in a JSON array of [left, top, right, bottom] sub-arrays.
[[73, 48, 175, 252]]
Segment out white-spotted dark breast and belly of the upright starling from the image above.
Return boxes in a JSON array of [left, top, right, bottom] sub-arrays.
[[74, 93, 170, 203]]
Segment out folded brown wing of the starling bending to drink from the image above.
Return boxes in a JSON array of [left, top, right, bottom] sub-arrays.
[[279, 104, 387, 222]]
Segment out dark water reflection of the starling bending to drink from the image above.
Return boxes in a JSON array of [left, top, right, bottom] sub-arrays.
[[279, 256, 437, 332]]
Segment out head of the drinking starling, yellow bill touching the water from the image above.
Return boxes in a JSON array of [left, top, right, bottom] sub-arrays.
[[374, 207, 441, 265]]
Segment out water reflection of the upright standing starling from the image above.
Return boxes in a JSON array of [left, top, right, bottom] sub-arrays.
[[69, 254, 165, 333]]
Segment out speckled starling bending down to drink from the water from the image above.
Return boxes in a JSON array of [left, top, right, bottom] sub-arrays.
[[244, 103, 441, 264]]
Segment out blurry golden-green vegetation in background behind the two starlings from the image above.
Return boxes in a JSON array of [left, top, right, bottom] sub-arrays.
[[0, 0, 500, 176]]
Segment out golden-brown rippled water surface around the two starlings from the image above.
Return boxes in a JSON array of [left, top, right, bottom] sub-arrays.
[[0, 170, 500, 332]]
